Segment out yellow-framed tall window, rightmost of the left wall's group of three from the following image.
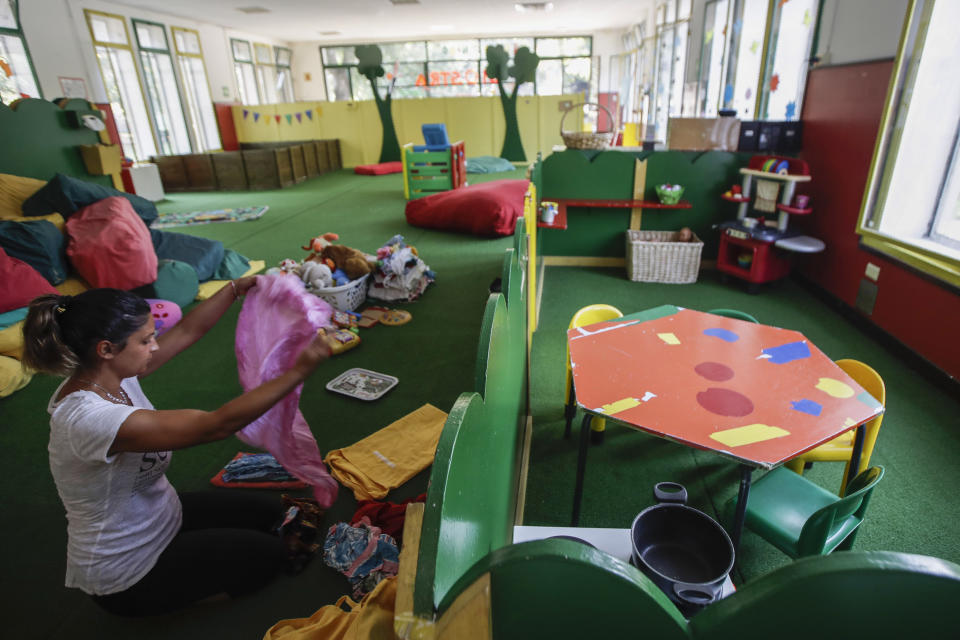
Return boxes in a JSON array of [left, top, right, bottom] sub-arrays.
[[171, 27, 221, 151]]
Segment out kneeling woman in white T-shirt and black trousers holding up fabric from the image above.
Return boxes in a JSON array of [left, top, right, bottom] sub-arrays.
[[23, 278, 330, 615]]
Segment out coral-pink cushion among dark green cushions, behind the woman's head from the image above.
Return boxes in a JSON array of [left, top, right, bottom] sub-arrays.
[[67, 196, 157, 289]]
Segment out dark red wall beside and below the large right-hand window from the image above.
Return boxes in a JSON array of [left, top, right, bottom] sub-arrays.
[[798, 60, 960, 379]]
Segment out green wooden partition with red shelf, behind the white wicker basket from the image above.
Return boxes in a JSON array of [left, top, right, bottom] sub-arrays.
[[540, 149, 753, 258]]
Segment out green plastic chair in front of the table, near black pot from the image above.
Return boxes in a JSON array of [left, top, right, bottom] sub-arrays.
[[727, 466, 883, 558]]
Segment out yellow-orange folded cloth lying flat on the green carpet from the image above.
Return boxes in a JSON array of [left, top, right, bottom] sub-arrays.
[[326, 404, 447, 500]]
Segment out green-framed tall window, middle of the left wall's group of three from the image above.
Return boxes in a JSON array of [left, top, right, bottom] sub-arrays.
[[132, 20, 192, 155]]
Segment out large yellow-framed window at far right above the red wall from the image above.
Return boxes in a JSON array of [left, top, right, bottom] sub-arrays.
[[858, 0, 960, 285]]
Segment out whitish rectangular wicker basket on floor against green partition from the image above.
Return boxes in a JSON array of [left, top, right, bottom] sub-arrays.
[[627, 229, 703, 284]]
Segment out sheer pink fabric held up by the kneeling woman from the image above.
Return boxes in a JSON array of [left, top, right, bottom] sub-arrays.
[[236, 275, 338, 508]]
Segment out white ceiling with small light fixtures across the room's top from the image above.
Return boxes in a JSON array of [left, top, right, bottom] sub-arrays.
[[105, 0, 645, 43]]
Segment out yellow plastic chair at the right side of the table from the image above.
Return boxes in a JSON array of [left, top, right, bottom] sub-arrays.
[[785, 360, 887, 496]]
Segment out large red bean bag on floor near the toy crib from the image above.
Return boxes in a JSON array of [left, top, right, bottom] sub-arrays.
[[406, 180, 530, 236]]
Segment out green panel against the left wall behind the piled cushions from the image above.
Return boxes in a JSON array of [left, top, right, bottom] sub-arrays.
[[0, 98, 113, 186]]
